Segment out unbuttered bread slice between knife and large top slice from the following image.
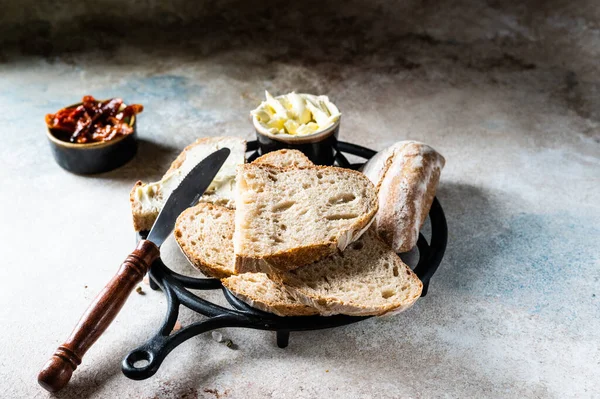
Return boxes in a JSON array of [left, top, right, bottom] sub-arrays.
[[174, 203, 234, 278]]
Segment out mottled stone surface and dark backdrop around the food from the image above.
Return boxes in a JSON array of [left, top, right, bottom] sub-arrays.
[[0, 0, 600, 399]]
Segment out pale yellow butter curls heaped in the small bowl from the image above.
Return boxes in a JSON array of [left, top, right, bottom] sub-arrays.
[[251, 91, 341, 136]]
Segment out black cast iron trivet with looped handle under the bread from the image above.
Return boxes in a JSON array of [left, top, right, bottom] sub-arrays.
[[121, 141, 448, 380]]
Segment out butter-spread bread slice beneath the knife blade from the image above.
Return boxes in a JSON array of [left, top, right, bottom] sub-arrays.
[[129, 137, 246, 231]]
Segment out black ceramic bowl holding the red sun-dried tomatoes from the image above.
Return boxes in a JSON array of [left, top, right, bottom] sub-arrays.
[[46, 103, 137, 175]]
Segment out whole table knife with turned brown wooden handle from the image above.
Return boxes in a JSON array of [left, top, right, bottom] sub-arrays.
[[38, 148, 230, 392]]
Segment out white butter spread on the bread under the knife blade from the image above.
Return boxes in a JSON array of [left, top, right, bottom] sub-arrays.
[[135, 138, 245, 216]]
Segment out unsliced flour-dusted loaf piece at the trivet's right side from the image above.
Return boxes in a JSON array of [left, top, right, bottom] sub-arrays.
[[363, 141, 446, 252]]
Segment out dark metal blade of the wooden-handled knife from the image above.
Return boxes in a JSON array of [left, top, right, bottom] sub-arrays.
[[147, 148, 231, 247]]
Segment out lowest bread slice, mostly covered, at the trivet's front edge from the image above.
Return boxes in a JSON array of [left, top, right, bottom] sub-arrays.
[[222, 273, 319, 316]]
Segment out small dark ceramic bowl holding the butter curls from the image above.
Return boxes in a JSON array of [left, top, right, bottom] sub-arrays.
[[252, 118, 341, 165]]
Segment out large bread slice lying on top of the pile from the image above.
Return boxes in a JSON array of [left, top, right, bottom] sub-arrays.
[[233, 164, 377, 274]]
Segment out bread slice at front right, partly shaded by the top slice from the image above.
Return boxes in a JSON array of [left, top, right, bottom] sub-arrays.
[[278, 229, 423, 316]]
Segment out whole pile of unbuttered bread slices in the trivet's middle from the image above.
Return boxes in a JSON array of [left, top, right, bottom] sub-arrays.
[[175, 150, 422, 316]]
